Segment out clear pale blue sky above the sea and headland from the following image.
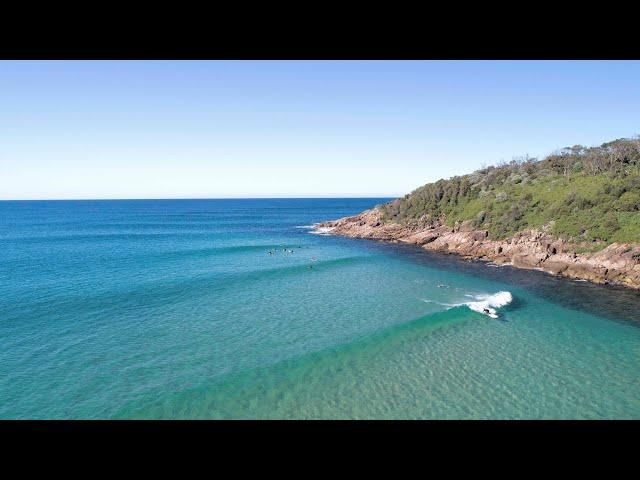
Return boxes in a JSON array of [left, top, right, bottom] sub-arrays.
[[0, 61, 640, 199]]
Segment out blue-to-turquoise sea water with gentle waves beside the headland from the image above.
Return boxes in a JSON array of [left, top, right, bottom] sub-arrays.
[[0, 199, 640, 418]]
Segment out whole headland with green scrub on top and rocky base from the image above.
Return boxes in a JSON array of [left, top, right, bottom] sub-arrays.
[[317, 138, 640, 289]]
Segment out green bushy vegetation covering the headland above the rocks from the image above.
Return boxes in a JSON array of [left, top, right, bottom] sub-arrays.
[[382, 138, 640, 249]]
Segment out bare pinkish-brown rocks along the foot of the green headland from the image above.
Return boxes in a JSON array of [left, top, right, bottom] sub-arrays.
[[316, 208, 640, 289]]
